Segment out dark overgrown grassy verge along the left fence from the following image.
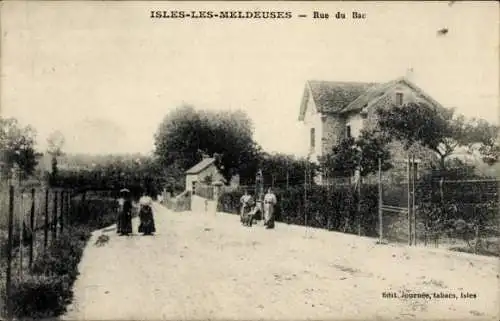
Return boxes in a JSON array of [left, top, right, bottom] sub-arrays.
[[3, 198, 116, 320]]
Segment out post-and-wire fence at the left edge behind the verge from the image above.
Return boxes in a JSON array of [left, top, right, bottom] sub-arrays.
[[0, 185, 76, 315]]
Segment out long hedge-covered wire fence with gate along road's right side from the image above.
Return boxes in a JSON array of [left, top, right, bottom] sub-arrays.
[[189, 158, 500, 253]]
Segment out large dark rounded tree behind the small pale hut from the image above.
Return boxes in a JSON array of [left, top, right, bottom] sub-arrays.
[[154, 106, 258, 181]]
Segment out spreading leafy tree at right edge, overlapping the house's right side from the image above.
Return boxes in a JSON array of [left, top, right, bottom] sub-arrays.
[[377, 103, 499, 169]]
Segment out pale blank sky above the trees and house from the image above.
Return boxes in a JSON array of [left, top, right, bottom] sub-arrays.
[[0, 1, 500, 154]]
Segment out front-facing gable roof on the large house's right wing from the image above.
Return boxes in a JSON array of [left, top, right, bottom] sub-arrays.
[[342, 77, 443, 113]]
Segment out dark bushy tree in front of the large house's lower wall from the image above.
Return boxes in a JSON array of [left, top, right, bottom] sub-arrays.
[[320, 130, 392, 177]]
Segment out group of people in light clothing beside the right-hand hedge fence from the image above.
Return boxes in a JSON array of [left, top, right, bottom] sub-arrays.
[[240, 188, 277, 229]]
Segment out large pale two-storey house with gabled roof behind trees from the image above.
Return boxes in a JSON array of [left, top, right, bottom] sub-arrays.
[[299, 77, 443, 181]]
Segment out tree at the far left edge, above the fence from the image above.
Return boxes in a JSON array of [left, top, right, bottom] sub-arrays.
[[0, 117, 42, 176]]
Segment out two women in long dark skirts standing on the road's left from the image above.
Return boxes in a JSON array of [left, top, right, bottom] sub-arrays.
[[116, 189, 156, 235]]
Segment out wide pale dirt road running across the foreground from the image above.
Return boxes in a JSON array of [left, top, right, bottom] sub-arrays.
[[64, 205, 499, 320]]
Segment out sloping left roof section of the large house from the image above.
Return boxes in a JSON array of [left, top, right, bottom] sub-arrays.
[[299, 80, 377, 120]]
